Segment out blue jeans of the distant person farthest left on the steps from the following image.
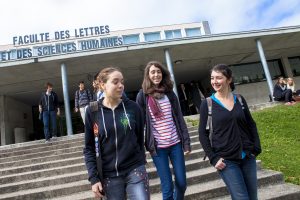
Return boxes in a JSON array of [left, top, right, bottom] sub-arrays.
[[43, 111, 57, 140]]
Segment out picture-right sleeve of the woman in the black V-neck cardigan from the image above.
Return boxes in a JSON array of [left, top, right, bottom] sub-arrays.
[[242, 96, 261, 156]]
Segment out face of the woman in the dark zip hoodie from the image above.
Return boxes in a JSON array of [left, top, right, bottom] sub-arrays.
[[101, 71, 124, 99]]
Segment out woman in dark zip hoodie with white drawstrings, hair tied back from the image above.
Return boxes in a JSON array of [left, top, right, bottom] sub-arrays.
[[84, 67, 150, 200]]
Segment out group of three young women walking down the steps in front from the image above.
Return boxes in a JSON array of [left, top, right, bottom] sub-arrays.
[[84, 61, 261, 200]]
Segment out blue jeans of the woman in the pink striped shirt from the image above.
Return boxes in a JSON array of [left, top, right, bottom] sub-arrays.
[[152, 143, 187, 200]]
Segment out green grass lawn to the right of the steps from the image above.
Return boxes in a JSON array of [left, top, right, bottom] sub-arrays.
[[252, 103, 300, 185]]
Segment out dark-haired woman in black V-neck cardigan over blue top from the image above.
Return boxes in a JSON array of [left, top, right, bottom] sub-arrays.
[[199, 64, 261, 200]]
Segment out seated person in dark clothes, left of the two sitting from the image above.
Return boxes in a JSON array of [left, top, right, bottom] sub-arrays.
[[273, 77, 294, 105]]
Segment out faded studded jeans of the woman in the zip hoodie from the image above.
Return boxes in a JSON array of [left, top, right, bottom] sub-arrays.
[[102, 165, 150, 200]]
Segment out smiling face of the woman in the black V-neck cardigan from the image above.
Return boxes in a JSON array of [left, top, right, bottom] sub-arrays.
[[210, 71, 232, 92]]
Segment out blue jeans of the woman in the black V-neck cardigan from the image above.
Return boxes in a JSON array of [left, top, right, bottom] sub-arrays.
[[219, 155, 257, 200]]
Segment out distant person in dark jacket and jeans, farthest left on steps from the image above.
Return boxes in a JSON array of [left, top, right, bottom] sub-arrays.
[[39, 83, 60, 143]]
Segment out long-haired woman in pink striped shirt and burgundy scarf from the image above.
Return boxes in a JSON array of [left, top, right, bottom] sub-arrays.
[[137, 61, 191, 200]]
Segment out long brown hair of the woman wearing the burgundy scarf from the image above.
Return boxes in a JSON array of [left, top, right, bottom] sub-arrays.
[[142, 61, 173, 94]]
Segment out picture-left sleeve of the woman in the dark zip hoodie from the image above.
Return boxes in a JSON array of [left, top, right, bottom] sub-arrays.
[[83, 107, 100, 185]]
